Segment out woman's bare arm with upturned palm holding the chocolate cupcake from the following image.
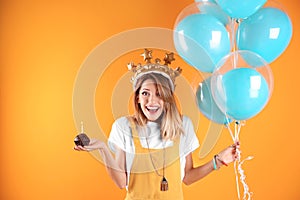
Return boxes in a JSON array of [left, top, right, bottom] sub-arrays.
[[74, 139, 127, 188]]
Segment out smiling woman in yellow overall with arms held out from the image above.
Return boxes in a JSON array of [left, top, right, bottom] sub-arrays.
[[75, 49, 238, 200]]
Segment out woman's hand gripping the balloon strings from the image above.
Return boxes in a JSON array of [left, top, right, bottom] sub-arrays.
[[217, 142, 239, 165]]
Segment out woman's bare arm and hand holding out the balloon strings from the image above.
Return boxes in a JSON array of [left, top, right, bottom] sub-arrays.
[[183, 143, 238, 185]]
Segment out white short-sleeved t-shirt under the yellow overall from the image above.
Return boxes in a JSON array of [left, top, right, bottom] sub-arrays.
[[108, 116, 199, 187]]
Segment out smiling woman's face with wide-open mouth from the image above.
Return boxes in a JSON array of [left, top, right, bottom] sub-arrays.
[[138, 79, 164, 121]]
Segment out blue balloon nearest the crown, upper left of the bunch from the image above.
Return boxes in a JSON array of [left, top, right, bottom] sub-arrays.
[[174, 14, 230, 72]]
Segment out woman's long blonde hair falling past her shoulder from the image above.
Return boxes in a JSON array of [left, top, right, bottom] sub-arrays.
[[134, 73, 183, 140]]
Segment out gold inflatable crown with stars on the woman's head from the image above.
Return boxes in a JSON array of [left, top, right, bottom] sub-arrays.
[[127, 49, 182, 91]]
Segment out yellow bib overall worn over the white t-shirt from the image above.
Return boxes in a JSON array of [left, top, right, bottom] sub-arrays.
[[125, 120, 183, 200]]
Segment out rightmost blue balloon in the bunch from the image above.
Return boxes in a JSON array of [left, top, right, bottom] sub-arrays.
[[236, 7, 292, 63]]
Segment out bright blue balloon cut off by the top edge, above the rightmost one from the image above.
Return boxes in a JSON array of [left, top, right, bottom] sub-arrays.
[[216, 0, 267, 19]]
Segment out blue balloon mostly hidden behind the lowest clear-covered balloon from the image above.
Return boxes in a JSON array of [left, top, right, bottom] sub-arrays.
[[196, 78, 231, 124]]
